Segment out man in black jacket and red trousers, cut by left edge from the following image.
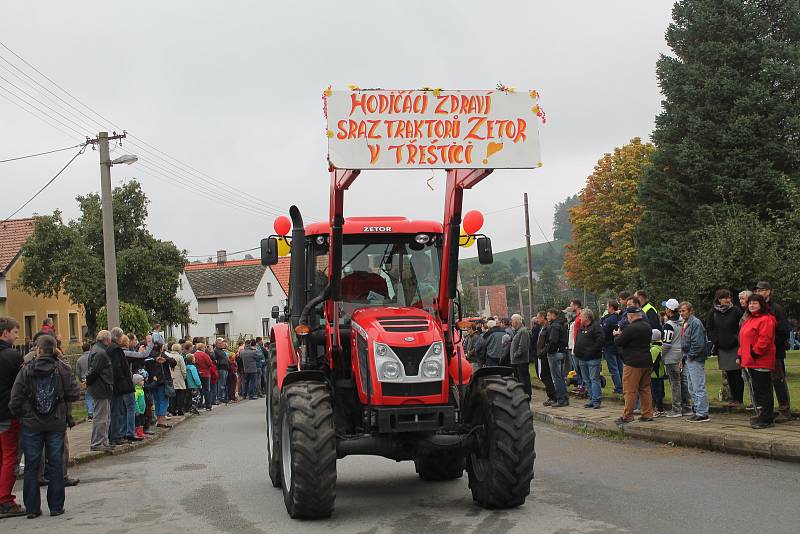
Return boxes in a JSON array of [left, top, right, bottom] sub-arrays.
[[0, 317, 25, 518]]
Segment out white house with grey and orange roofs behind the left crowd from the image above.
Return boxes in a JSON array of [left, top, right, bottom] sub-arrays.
[[175, 250, 289, 338]]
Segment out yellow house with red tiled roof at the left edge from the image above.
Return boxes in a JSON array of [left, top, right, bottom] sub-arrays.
[[0, 219, 86, 345]]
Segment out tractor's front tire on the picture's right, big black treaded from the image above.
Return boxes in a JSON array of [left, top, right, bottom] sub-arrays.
[[467, 376, 536, 508]]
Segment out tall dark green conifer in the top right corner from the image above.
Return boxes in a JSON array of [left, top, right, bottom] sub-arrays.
[[637, 0, 800, 294]]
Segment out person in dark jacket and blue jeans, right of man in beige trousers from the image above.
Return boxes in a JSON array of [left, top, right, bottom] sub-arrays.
[[106, 328, 136, 445]]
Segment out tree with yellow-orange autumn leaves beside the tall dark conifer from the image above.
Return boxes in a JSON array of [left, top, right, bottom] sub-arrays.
[[565, 137, 654, 293]]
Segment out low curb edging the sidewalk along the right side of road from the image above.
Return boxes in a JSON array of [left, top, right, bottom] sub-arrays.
[[533, 410, 800, 463]]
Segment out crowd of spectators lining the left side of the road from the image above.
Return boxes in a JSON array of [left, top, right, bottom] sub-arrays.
[[0, 317, 268, 519]]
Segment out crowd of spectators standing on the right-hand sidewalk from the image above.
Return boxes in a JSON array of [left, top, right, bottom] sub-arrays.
[[464, 281, 792, 429]]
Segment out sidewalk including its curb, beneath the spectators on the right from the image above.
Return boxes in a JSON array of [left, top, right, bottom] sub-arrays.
[[531, 389, 800, 462]]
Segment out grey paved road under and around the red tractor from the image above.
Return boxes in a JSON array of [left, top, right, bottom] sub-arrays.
[[6, 401, 800, 534]]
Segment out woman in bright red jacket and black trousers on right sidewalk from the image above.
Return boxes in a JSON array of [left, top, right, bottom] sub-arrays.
[[737, 293, 776, 429]]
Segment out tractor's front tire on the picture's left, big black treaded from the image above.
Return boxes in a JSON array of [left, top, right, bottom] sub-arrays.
[[280, 381, 336, 519]]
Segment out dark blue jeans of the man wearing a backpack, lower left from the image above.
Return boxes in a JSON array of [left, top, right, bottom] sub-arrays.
[[22, 427, 64, 513]]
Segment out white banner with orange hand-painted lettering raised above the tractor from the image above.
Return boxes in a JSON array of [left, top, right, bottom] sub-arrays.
[[326, 89, 544, 169]]
